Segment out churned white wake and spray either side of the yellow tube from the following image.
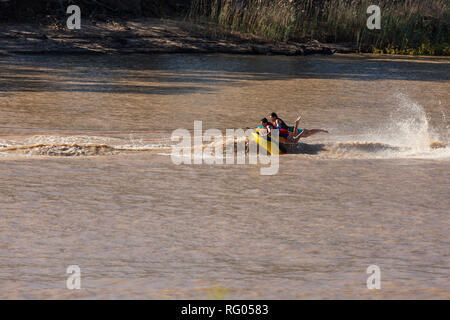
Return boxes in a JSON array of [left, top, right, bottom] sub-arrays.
[[0, 95, 450, 159]]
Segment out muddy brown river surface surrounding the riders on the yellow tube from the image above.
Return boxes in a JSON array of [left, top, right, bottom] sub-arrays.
[[0, 55, 450, 299]]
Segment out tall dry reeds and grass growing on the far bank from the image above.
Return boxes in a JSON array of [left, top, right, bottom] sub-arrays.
[[189, 0, 450, 55]]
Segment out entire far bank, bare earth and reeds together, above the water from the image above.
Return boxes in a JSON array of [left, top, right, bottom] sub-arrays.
[[0, 0, 450, 56]]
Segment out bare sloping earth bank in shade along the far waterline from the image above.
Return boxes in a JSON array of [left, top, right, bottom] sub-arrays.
[[0, 18, 356, 56]]
